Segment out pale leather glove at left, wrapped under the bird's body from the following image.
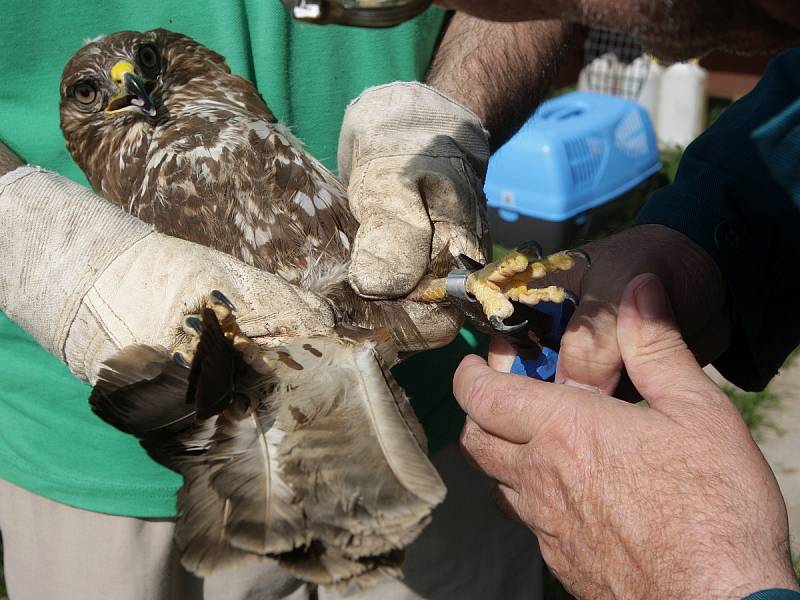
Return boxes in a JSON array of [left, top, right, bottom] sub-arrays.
[[0, 167, 334, 383]]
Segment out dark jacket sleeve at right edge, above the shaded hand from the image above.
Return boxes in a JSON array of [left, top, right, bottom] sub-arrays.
[[637, 50, 800, 390]]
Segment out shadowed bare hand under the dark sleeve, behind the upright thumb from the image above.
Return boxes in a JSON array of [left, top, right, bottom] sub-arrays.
[[490, 225, 731, 394]]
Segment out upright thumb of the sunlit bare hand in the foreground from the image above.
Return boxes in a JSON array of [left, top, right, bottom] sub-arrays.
[[617, 273, 721, 418]]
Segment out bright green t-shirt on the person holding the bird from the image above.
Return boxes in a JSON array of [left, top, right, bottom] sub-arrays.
[[0, 0, 482, 517]]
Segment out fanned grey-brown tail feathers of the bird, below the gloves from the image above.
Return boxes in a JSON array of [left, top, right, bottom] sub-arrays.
[[92, 311, 445, 586]]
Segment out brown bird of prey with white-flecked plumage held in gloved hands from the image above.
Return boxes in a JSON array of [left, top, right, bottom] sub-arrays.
[[61, 29, 580, 585]]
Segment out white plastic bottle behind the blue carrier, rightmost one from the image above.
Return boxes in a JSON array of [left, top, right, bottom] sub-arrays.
[[656, 60, 708, 148]]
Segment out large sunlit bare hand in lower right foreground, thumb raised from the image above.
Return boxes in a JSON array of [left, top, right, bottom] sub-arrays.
[[454, 274, 800, 598]]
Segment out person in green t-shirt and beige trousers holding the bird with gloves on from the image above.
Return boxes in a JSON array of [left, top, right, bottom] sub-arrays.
[[0, 0, 565, 600]]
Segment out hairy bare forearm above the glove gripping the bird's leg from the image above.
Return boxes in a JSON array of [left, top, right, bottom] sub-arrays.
[[426, 13, 571, 151]]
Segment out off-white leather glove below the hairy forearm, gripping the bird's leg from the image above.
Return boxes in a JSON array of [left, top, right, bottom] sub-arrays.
[[338, 82, 490, 298]]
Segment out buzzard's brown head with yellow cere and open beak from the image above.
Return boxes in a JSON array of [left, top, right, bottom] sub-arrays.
[[61, 29, 250, 192]]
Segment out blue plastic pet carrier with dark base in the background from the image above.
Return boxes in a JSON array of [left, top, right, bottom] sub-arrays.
[[485, 92, 661, 252]]
